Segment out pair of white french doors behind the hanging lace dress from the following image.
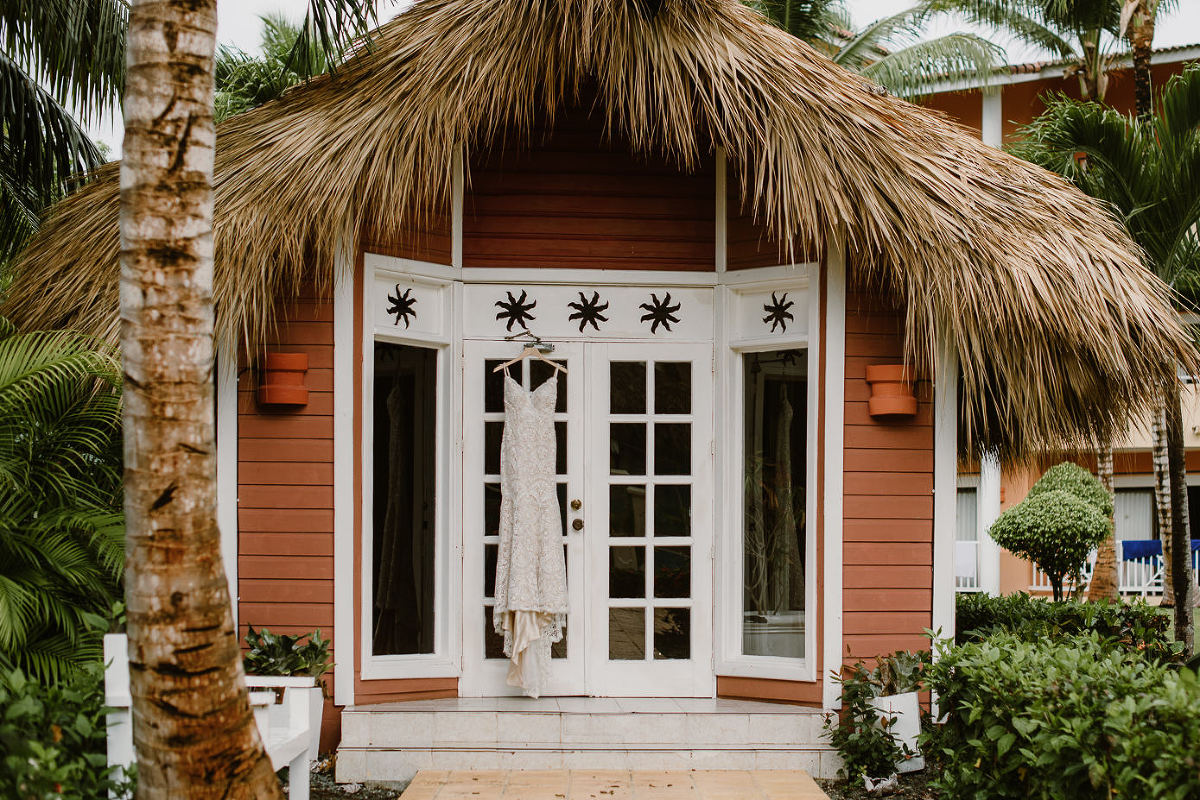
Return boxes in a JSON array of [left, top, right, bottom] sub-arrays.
[[460, 341, 715, 697]]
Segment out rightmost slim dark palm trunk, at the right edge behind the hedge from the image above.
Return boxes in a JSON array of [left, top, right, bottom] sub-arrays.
[[1163, 380, 1195, 657]]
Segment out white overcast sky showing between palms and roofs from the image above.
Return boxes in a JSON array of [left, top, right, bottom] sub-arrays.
[[91, 0, 1200, 157]]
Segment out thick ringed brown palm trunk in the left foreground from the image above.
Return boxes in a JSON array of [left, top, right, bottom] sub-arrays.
[[120, 0, 282, 798]]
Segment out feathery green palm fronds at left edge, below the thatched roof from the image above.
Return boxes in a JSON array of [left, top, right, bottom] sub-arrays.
[[0, 319, 125, 681]]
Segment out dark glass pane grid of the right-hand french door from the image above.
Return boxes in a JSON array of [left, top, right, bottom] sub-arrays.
[[606, 360, 694, 661]]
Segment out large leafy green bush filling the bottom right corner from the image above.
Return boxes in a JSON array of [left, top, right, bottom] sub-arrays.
[[922, 633, 1200, 800]]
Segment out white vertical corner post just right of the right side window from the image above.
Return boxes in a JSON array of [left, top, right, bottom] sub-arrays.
[[821, 231, 849, 709]]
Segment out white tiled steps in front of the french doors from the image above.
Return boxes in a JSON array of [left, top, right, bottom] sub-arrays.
[[337, 697, 839, 796]]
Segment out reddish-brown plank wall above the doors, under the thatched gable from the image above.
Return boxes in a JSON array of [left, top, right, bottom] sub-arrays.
[[463, 112, 715, 271]]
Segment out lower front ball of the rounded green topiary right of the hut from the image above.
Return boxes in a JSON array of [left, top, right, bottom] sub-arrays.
[[988, 489, 1112, 600]]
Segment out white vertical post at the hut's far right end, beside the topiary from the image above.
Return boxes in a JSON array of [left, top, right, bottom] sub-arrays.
[[932, 337, 959, 636]]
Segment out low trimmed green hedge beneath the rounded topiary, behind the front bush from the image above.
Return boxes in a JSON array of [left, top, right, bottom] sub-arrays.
[[954, 593, 1182, 661]]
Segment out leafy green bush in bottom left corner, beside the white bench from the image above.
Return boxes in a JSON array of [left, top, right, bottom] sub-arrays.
[[0, 662, 132, 800]]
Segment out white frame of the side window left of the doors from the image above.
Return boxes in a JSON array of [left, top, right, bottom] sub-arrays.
[[358, 253, 462, 680]]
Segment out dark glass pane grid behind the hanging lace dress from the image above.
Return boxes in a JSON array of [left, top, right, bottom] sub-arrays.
[[480, 359, 571, 660]]
